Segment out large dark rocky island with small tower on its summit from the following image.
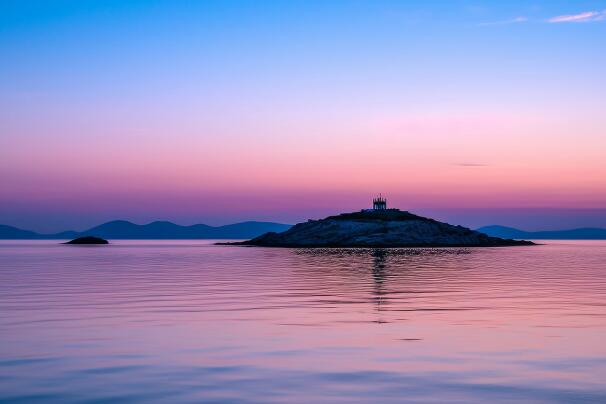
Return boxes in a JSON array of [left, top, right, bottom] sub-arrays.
[[226, 197, 534, 248]]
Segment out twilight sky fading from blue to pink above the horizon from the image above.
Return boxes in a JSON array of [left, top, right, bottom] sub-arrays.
[[0, 0, 606, 232]]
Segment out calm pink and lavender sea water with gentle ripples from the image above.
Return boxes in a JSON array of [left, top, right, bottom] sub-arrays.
[[0, 241, 606, 403]]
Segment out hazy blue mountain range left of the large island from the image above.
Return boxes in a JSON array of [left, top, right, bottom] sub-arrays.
[[0, 220, 291, 240]]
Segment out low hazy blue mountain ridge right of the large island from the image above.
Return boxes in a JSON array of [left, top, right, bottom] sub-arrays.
[[478, 226, 606, 240]]
